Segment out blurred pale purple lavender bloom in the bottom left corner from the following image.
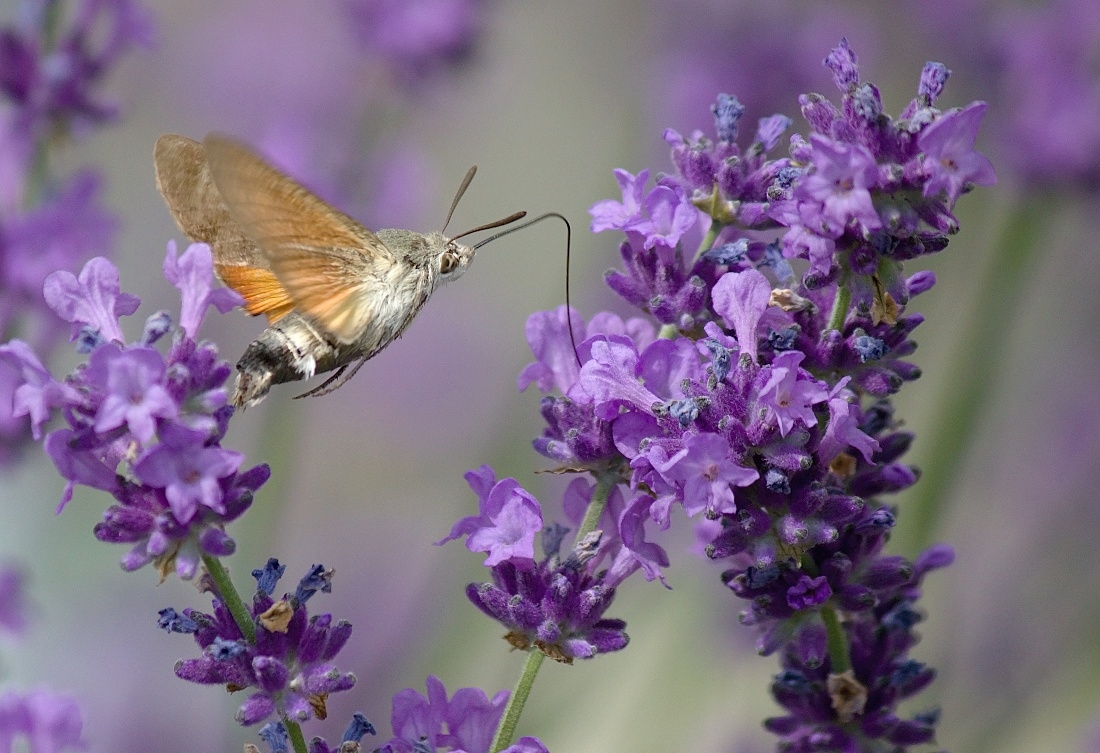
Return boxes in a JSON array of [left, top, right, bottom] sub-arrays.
[[0, 688, 87, 753]]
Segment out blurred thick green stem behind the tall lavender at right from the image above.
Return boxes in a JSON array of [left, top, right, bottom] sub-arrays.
[[895, 193, 1042, 553]]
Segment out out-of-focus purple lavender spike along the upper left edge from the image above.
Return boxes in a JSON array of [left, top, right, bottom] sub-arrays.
[[0, 0, 152, 464]]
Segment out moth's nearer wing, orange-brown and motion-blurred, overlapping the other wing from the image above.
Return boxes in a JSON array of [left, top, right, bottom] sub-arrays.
[[202, 134, 397, 344]]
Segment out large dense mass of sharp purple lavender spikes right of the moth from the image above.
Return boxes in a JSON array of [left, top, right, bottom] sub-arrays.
[[503, 41, 993, 752]]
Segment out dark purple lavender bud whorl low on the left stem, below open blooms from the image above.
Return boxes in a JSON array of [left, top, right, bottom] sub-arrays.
[[160, 560, 355, 726]]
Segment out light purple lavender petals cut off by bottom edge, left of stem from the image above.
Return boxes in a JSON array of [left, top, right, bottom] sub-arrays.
[[378, 675, 548, 753]]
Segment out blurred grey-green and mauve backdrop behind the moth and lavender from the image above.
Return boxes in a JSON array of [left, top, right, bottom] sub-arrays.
[[0, 0, 1100, 753]]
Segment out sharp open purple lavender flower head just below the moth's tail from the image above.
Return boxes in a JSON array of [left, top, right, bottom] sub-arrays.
[[0, 244, 270, 578]]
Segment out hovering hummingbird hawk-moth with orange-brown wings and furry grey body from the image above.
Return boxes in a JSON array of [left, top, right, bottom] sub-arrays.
[[153, 134, 528, 408]]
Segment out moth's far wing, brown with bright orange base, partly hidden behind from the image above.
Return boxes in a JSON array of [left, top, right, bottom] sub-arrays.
[[153, 133, 294, 323]]
